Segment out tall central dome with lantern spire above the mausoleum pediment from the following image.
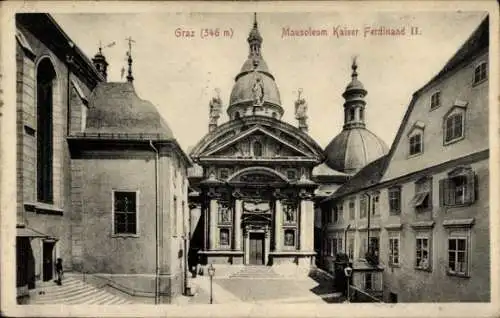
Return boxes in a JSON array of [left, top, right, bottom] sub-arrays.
[[227, 14, 284, 120]]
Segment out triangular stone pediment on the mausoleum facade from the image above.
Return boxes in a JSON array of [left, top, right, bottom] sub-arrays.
[[201, 126, 308, 159]]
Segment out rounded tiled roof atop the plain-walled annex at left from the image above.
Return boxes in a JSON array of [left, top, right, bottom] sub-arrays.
[[85, 82, 174, 139]]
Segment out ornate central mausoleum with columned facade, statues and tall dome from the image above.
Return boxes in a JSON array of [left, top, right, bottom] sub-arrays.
[[190, 14, 324, 268]]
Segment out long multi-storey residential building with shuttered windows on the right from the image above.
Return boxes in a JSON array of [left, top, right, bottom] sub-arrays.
[[322, 17, 491, 302]]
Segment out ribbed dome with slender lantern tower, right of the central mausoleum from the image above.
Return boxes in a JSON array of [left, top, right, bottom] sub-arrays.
[[325, 59, 389, 174]]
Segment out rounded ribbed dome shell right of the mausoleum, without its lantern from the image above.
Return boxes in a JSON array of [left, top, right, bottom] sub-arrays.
[[325, 128, 389, 174]]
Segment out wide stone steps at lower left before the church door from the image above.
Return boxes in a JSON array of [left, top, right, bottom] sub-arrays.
[[29, 276, 135, 305]]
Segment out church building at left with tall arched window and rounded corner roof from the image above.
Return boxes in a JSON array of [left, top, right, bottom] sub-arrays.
[[16, 14, 191, 302]]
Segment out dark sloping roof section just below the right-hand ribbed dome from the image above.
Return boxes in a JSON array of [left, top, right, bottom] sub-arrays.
[[325, 156, 387, 201]]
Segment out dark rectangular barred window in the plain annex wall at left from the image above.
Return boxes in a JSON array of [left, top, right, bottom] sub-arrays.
[[113, 191, 137, 234]]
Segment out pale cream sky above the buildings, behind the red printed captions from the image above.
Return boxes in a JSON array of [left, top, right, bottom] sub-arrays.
[[53, 10, 486, 150]]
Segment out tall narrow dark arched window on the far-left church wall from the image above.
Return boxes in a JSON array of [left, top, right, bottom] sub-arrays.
[[36, 58, 56, 203]]
